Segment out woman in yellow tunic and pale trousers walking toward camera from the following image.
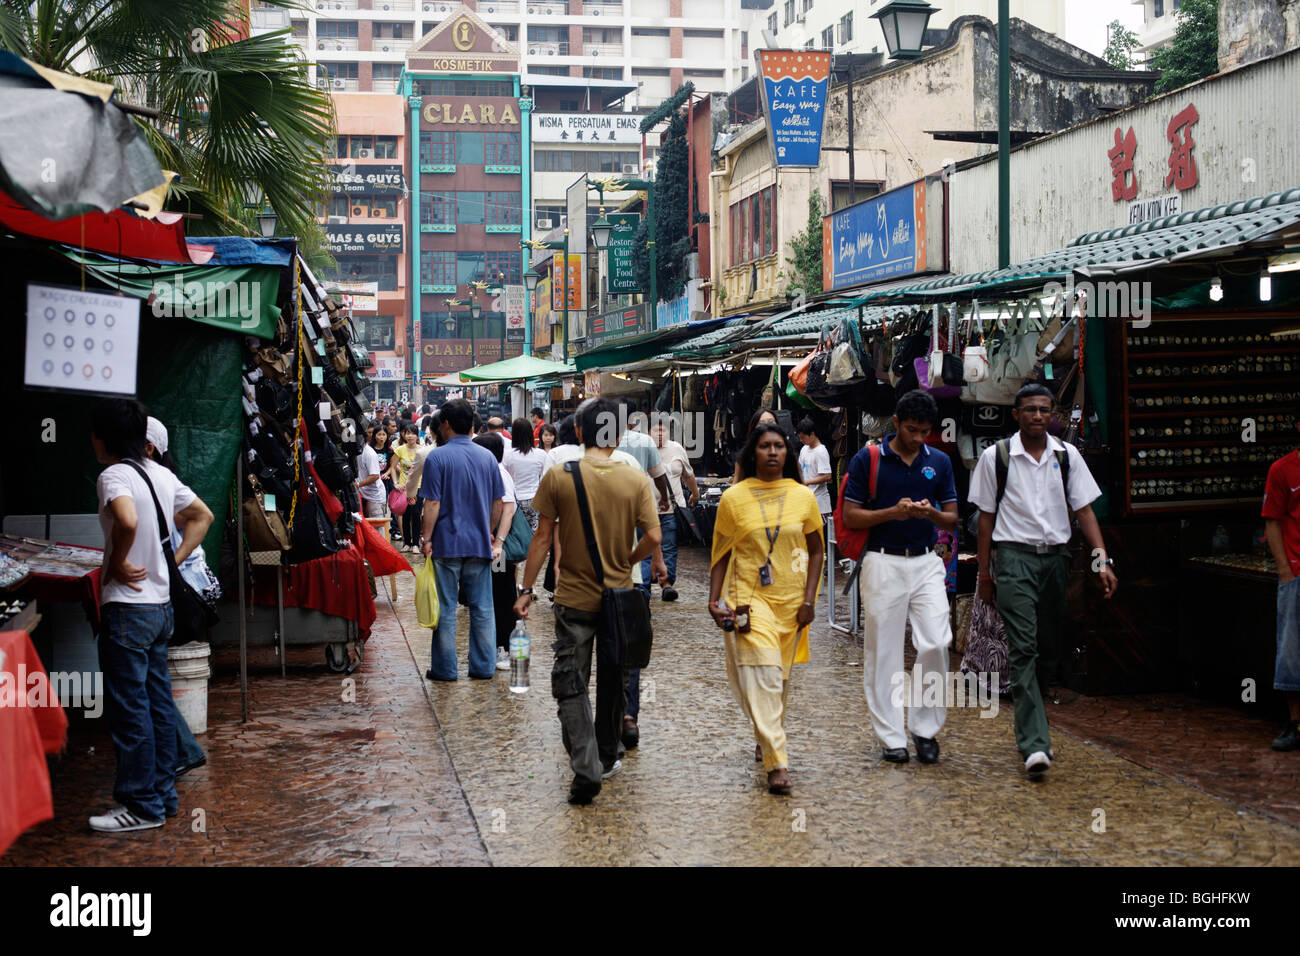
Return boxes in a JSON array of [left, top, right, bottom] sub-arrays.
[[709, 424, 824, 795]]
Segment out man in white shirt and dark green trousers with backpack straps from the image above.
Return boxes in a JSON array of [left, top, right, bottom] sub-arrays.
[[970, 384, 1119, 777]]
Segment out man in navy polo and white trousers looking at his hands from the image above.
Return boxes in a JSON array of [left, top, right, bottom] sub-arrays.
[[844, 389, 957, 763]]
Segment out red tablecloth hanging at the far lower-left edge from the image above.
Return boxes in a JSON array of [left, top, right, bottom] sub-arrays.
[[0, 631, 68, 855]]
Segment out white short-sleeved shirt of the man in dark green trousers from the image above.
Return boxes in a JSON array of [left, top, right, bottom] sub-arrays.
[[967, 432, 1101, 545]]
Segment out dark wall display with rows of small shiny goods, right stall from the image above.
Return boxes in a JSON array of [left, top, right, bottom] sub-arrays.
[[1123, 313, 1300, 514]]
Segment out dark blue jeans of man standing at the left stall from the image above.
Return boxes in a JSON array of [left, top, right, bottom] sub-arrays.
[[99, 602, 178, 819]]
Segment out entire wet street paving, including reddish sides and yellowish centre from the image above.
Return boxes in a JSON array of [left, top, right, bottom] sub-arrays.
[[10, 549, 1300, 866]]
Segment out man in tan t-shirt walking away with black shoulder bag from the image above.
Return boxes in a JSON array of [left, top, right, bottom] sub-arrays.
[[515, 398, 668, 804]]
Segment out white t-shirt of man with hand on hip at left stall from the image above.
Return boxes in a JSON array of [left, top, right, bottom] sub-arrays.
[[95, 460, 198, 604]]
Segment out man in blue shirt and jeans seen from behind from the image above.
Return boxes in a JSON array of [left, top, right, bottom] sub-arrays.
[[420, 398, 506, 680]]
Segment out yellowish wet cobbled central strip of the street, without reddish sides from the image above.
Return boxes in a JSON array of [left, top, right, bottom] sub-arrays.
[[399, 549, 1300, 865]]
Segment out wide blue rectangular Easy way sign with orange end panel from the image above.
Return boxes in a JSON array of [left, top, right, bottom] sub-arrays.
[[822, 177, 945, 291]]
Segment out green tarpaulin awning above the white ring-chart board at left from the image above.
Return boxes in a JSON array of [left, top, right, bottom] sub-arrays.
[[62, 250, 281, 338]]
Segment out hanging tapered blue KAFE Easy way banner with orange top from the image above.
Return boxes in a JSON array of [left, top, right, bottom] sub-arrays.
[[755, 49, 831, 166]]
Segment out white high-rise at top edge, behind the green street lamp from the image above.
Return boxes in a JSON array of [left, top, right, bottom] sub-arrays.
[[749, 0, 1066, 53]]
